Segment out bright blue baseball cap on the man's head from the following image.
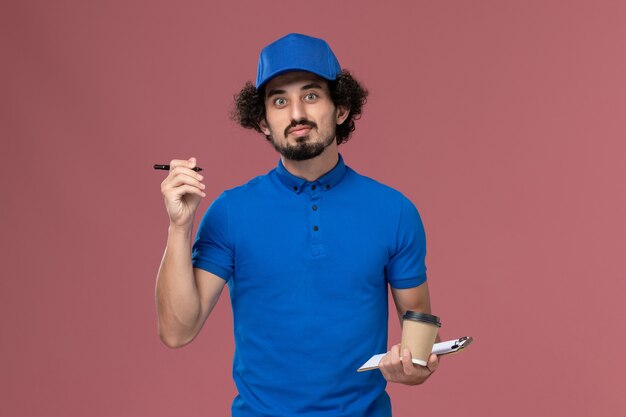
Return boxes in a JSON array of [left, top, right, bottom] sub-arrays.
[[256, 33, 341, 88]]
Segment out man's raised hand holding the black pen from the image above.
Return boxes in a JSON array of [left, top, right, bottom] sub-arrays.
[[161, 157, 206, 226]]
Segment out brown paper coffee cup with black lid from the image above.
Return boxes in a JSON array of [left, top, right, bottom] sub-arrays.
[[400, 310, 441, 366]]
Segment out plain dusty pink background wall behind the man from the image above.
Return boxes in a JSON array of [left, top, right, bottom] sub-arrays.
[[0, 0, 626, 417]]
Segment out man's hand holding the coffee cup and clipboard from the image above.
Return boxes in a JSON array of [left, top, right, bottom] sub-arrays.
[[378, 345, 439, 385]]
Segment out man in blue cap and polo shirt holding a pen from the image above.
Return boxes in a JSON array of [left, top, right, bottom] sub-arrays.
[[156, 34, 438, 417]]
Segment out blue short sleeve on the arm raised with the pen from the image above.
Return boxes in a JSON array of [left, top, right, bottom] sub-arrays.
[[191, 194, 234, 281]]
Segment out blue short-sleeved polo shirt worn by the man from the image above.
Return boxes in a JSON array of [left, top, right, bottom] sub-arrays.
[[193, 156, 426, 417]]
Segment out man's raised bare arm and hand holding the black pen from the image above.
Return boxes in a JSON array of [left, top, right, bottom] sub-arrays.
[[156, 158, 225, 348]]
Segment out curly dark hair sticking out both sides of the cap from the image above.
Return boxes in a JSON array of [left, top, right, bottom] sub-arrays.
[[230, 70, 368, 145]]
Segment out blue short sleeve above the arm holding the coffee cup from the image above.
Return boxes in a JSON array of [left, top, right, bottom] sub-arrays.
[[386, 196, 426, 289]]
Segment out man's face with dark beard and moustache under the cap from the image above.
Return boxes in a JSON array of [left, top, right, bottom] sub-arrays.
[[259, 71, 348, 161]]
